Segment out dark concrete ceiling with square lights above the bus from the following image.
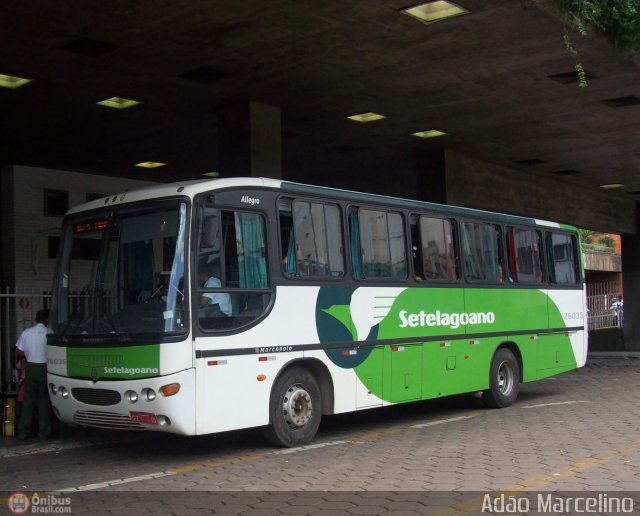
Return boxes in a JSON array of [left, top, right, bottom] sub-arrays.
[[0, 0, 640, 199]]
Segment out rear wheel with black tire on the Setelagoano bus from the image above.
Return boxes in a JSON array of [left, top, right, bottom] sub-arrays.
[[482, 348, 520, 408]]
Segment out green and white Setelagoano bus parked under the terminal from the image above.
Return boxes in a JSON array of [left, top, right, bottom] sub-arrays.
[[47, 178, 587, 447]]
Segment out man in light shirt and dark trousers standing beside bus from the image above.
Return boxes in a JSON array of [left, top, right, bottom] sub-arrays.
[[16, 310, 51, 440]]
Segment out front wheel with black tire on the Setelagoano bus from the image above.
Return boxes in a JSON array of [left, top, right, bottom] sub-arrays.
[[264, 367, 322, 448]]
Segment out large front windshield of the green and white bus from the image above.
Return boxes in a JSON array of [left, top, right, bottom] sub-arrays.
[[53, 200, 188, 339]]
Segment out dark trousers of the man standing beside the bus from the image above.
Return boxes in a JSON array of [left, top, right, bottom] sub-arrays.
[[18, 364, 51, 439]]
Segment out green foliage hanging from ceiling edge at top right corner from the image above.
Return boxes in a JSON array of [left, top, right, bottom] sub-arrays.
[[556, 0, 640, 88]]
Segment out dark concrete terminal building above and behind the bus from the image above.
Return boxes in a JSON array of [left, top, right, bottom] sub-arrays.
[[0, 0, 640, 400]]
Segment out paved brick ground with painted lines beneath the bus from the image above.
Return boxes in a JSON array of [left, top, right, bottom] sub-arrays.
[[0, 355, 640, 516]]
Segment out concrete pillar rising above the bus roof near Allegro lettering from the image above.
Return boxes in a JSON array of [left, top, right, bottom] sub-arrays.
[[218, 102, 282, 179]]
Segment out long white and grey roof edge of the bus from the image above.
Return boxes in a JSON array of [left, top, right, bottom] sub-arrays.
[[67, 177, 575, 229]]
